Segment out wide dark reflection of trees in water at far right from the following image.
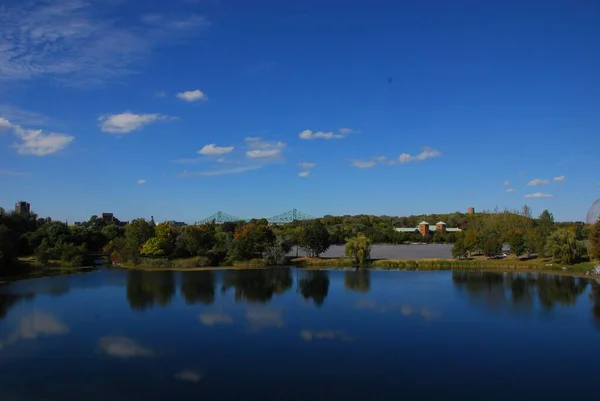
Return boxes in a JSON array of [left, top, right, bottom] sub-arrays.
[[452, 271, 588, 310]]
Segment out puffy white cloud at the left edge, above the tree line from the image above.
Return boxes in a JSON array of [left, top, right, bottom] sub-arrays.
[[0, 117, 75, 156]]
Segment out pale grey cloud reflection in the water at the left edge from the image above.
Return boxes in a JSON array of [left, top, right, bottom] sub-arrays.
[[0, 312, 69, 350]]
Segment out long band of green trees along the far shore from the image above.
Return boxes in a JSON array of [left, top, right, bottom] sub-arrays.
[[0, 207, 600, 272]]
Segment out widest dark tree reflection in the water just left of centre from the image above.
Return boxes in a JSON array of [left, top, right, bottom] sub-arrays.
[[222, 267, 292, 303]]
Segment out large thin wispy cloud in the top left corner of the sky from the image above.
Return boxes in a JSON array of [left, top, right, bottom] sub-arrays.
[[0, 0, 209, 86]]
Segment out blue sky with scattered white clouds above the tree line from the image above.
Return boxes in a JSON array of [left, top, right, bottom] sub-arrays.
[[0, 0, 600, 222]]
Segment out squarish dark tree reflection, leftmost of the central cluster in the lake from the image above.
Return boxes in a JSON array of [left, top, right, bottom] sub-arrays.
[[127, 270, 175, 311]]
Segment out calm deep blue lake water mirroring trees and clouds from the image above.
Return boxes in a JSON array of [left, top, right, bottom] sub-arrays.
[[0, 268, 600, 401]]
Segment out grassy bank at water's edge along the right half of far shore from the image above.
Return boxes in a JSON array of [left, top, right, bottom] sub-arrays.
[[291, 258, 594, 274]]
